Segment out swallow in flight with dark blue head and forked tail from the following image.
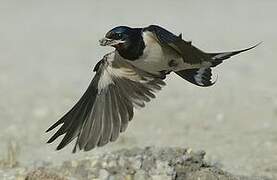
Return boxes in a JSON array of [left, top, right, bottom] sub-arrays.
[[46, 25, 258, 152]]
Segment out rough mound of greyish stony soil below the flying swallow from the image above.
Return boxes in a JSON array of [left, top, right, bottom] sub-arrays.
[[23, 147, 263, 180]]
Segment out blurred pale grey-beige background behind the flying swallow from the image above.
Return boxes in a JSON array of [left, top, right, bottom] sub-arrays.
[[0, 0, 277, 178]]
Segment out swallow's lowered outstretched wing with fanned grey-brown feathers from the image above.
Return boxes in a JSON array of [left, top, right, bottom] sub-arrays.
[[46, 52, 165, 152]]
